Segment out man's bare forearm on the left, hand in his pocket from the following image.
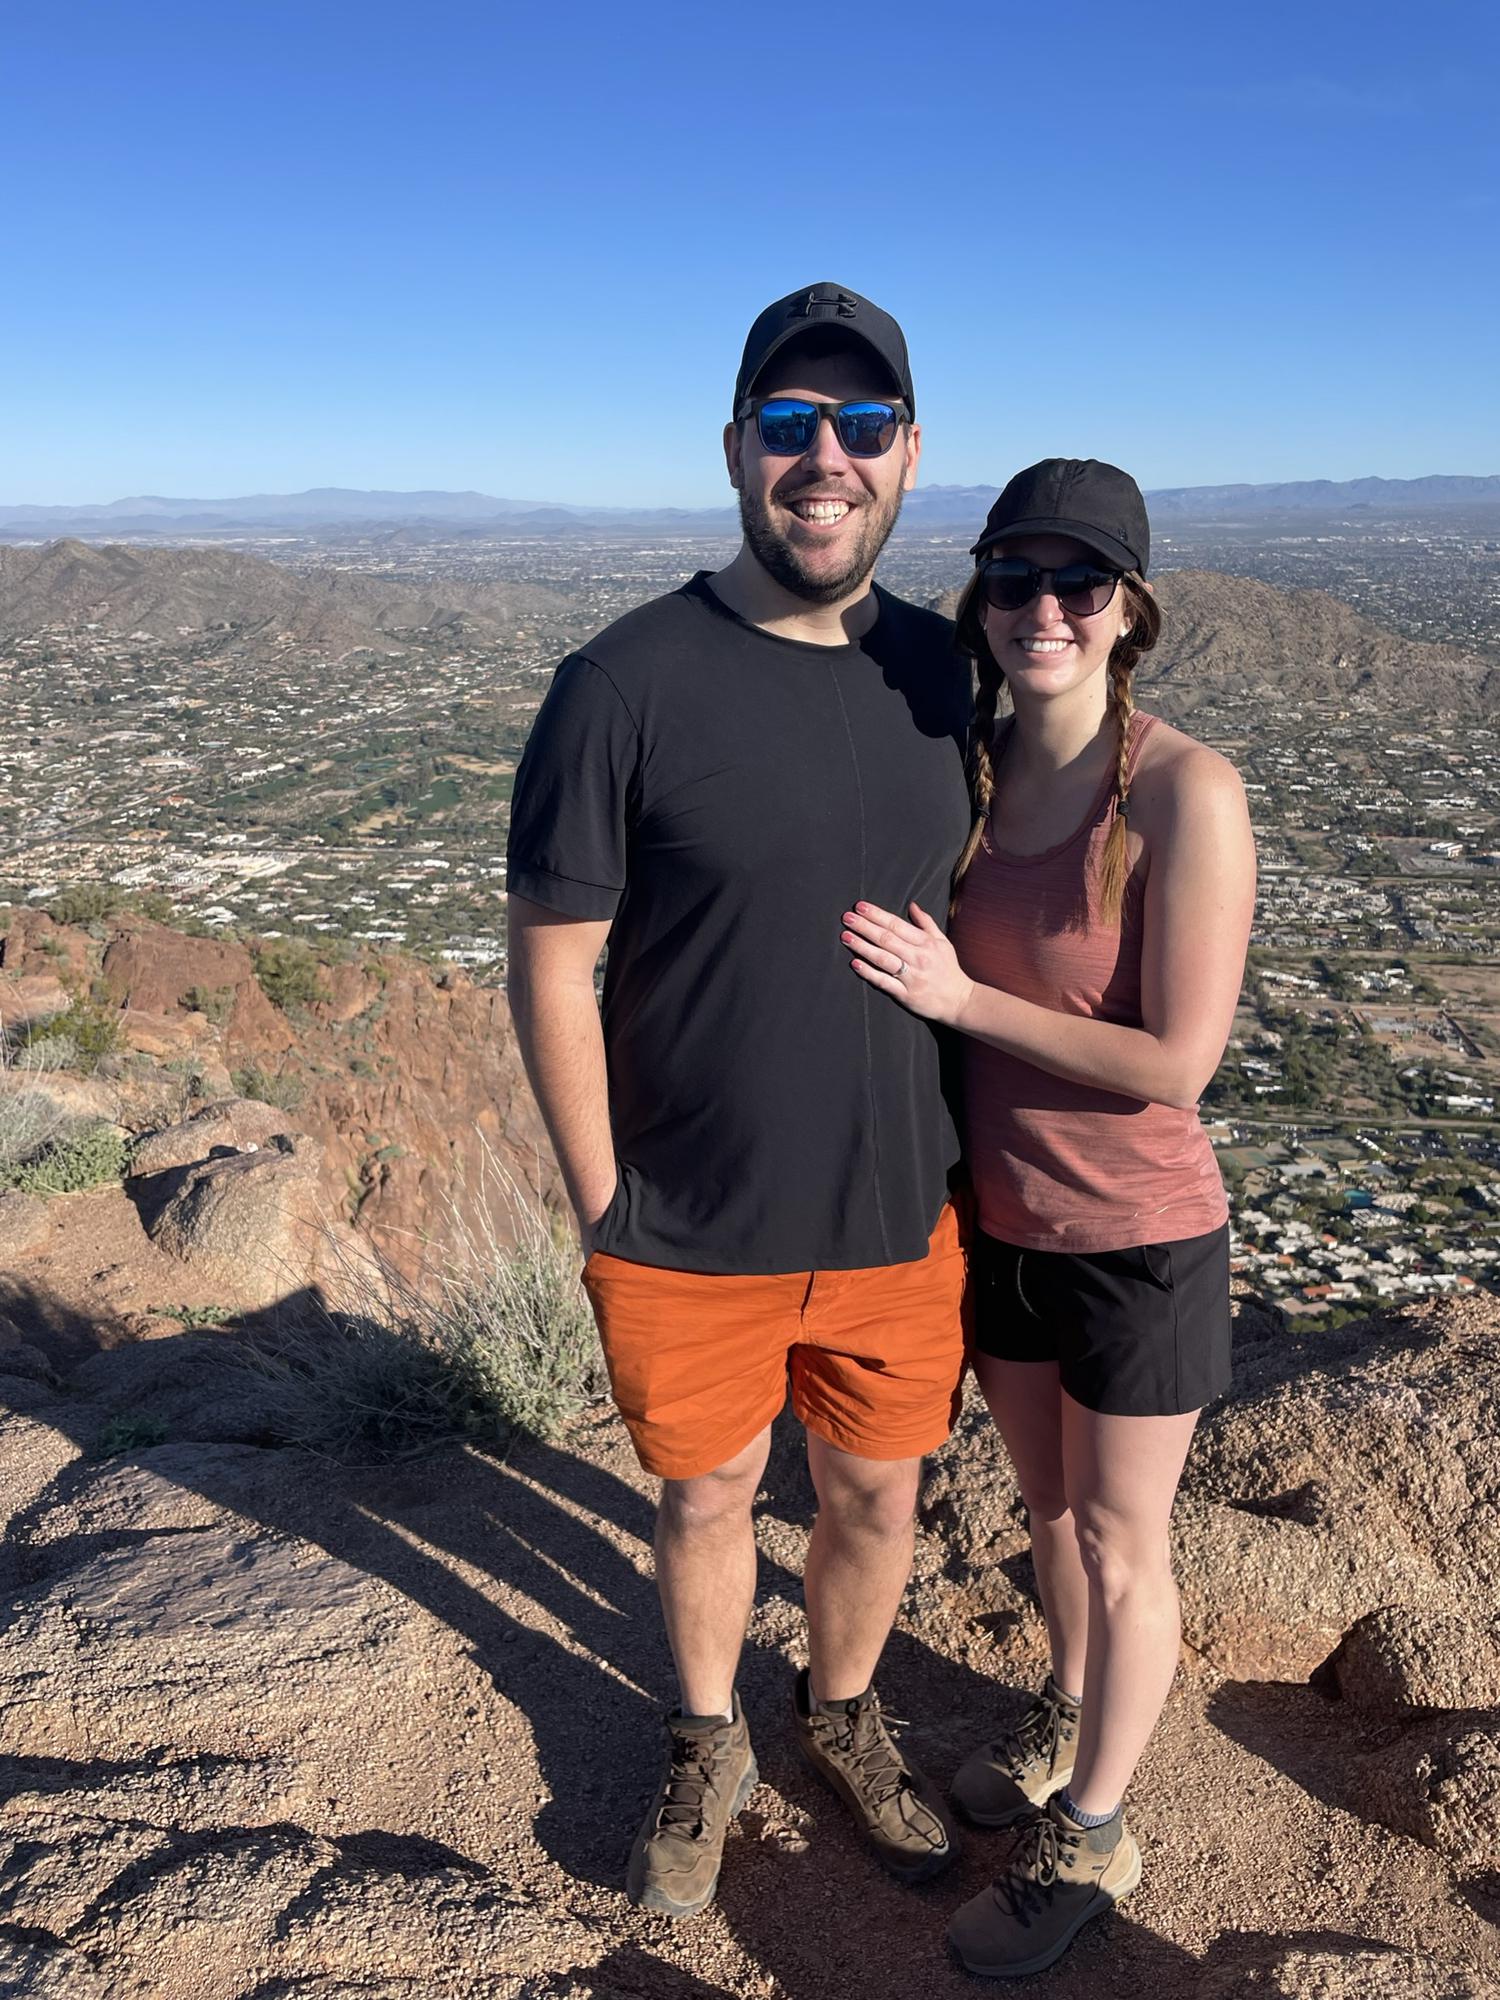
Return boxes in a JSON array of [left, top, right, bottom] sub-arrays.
[[506, 896, 616, 1256]]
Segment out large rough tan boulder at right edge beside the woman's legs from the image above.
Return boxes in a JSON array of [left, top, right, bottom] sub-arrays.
[[1174, 1298, 1500, 1708]]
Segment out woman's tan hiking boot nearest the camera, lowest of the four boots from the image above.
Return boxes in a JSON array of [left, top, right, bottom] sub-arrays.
[[948, 1798, 1140, 1980]]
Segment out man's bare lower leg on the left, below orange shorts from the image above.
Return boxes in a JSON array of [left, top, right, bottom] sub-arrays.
[[656, 1426, 770, 1716]]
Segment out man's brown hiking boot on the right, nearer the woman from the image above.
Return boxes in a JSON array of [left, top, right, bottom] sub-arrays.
[[794, 1668, 958, 1882]]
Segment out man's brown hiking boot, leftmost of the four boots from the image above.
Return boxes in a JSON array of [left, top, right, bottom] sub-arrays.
[[626, 1694, 760, 1916]]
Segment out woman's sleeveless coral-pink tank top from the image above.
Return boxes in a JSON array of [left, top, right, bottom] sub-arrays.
[[952, 716, 1228, 1252]]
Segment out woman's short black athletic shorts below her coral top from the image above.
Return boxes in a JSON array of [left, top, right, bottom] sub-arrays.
[[970, 1222, 1230, 1416]]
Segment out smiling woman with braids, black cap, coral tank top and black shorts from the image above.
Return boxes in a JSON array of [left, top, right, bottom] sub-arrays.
[[842, 458, 1254, 1974]]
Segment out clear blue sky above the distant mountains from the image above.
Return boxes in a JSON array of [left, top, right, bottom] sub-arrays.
[[0, 0, 1500, 504]]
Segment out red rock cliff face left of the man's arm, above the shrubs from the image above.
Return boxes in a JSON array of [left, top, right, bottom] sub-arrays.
[[0, 910, 562, 1276]]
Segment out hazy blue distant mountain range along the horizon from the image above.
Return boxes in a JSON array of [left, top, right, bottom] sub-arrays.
[[0, 474, 1500, 540]]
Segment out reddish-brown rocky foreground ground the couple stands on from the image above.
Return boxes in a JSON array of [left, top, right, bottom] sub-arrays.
[[0, 1200, 1500, 2000]]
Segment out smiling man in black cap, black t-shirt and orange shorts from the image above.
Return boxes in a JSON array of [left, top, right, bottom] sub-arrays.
[[508, 284, 970, 1916]]
